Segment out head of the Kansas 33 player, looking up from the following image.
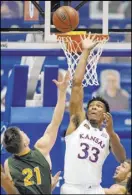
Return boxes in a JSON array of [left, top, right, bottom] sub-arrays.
[[86, 96, 110, 125]]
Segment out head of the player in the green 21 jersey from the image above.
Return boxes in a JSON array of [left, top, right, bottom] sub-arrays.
[[3, 127, 30, 154]]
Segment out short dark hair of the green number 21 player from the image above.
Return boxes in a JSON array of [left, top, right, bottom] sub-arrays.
[[3, 127, 22, 154]]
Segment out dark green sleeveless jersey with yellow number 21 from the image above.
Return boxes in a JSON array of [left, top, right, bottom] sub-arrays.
[[8, 148, 51, 194]]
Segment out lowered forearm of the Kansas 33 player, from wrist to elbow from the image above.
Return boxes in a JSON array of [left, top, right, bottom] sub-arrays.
[[110, 133, 126, 163]]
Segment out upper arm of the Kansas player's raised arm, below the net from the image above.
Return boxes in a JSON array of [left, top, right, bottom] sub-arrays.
[[69, 86, 84, 116]]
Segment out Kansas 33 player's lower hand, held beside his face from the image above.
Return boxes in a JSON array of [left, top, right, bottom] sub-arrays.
[[104, 112, 114, 136]]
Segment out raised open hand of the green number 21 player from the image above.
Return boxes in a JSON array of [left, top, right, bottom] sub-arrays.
[[53, 71, 70, 92]]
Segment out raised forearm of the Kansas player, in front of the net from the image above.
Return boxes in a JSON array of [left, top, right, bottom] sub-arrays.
[[73, 49, 91, 84]]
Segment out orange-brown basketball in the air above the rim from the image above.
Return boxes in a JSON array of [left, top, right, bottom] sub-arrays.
[[52, 6, 79, 32]]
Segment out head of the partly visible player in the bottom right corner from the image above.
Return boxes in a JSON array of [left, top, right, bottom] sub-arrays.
[[113, 159, 131, 183]]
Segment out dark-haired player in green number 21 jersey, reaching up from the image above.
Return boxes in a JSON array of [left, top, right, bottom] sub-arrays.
[[3, 72, 70, 194]]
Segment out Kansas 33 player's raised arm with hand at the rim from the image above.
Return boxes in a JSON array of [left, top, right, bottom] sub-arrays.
[[70, 33, 97, 117]]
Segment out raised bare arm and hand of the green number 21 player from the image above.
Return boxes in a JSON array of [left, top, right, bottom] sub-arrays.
[[35, 72, 70, 155]]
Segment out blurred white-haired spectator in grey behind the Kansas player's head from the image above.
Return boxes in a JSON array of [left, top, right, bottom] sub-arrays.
[[92, 69, 129, 111]]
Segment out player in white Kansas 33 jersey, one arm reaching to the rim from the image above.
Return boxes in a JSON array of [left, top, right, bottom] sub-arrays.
[[61, 33, 126, 194]]
